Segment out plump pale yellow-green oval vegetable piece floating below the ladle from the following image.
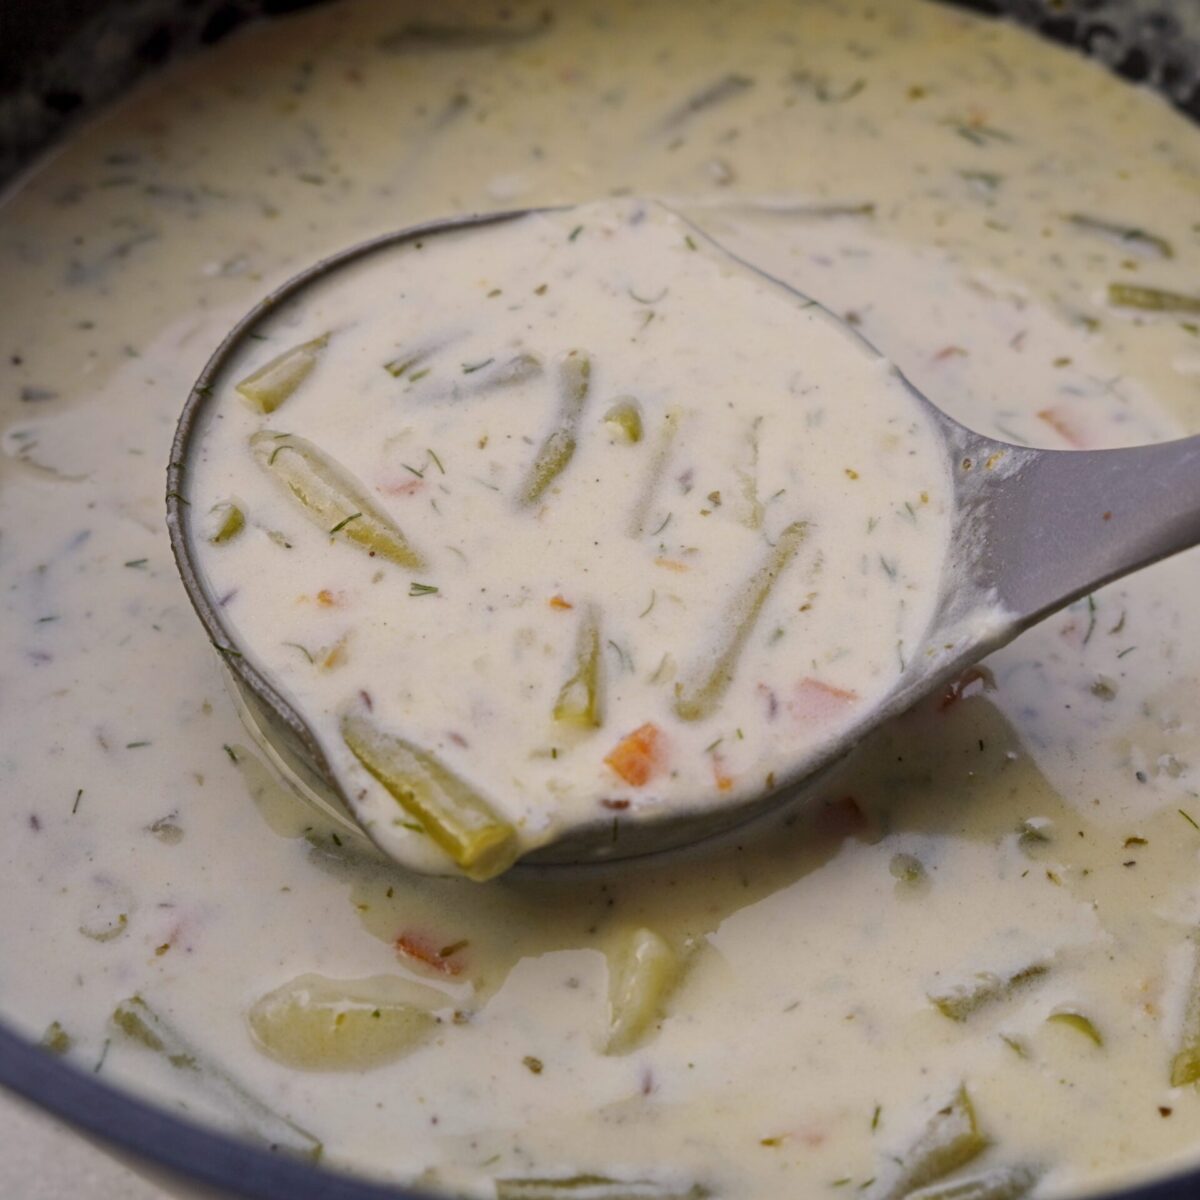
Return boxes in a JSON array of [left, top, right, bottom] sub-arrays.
[[246, 974, 439, 1070]]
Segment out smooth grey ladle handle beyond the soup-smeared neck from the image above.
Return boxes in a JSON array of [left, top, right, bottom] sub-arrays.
[[986, 436, 1200, 625]]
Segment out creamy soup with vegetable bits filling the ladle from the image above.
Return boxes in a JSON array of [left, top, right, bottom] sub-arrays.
[[186, 200, 952, 876]]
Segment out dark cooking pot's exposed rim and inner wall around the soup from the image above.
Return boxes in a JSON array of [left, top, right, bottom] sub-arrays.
[[0, 0, 1200, 1200]]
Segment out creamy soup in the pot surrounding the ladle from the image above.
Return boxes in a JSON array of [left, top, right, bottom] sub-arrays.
[[0, 0, 1200, 1200]]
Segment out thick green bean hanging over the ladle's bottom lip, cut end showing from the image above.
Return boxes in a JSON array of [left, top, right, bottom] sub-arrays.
[[342, 713, 518, 882]]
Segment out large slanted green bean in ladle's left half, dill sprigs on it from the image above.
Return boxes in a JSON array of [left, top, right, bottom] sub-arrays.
[[250, 430, 427, 571]]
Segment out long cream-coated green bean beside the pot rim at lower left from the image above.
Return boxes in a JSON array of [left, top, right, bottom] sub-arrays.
[[113, 996, 322, 1160]]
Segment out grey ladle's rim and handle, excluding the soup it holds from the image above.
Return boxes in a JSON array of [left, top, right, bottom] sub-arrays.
[[167, 209, 1200, 865]]
